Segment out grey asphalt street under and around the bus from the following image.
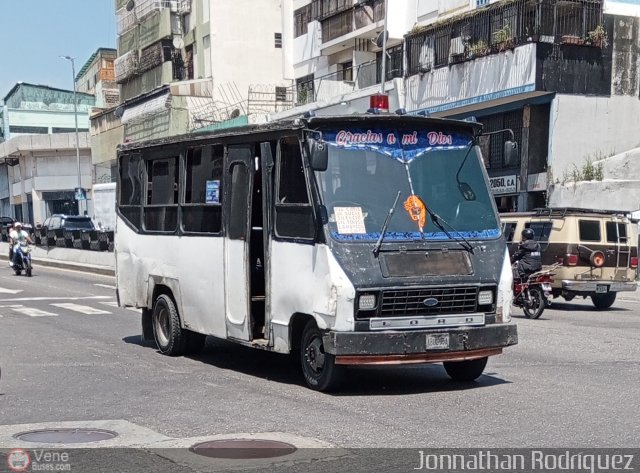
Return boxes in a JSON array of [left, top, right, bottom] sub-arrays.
[[0, 266, 640, 468]]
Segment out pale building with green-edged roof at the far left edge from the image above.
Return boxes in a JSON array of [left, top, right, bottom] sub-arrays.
[[0, 83, 95, 223]]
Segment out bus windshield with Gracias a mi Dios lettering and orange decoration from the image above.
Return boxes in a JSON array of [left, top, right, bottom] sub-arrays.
[[316, 128, 500, 241]]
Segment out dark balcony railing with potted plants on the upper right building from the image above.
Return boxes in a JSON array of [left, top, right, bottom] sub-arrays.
[[405, 0, 606, 75]]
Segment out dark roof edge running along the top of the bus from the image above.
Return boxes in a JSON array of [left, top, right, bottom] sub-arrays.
[[118, 114, 482, 151]]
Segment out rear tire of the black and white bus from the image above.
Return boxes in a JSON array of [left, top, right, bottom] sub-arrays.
[[153, 294, 187, 356]]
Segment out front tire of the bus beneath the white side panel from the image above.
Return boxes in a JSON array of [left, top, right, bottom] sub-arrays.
[[300, 320, 344, 391]]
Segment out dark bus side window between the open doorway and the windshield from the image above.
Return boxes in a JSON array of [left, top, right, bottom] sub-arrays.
[[275, 137, 316, 239]]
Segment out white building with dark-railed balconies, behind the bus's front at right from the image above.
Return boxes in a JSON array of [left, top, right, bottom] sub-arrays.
[[271, 0, 640, 211]]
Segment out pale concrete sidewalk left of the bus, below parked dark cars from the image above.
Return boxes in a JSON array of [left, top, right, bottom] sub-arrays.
[[0, 242, 116, 276]]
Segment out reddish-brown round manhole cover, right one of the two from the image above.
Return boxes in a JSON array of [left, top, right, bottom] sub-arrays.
[[189, 439, 297, 459]]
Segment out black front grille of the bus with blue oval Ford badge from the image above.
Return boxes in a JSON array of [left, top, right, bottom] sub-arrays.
[[377, 287, 478, 317]]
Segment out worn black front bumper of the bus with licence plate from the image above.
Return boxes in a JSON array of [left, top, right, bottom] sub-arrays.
[[323, 323, 518, 365]]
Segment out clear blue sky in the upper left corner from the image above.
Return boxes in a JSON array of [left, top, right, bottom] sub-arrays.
[[0, 0, 117, 100]]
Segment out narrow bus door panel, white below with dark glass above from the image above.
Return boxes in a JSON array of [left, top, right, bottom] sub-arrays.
[[224, 145, 254, 340]]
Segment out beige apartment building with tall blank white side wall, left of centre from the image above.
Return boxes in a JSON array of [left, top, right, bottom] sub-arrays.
[[91, 0, 286, 177]]
